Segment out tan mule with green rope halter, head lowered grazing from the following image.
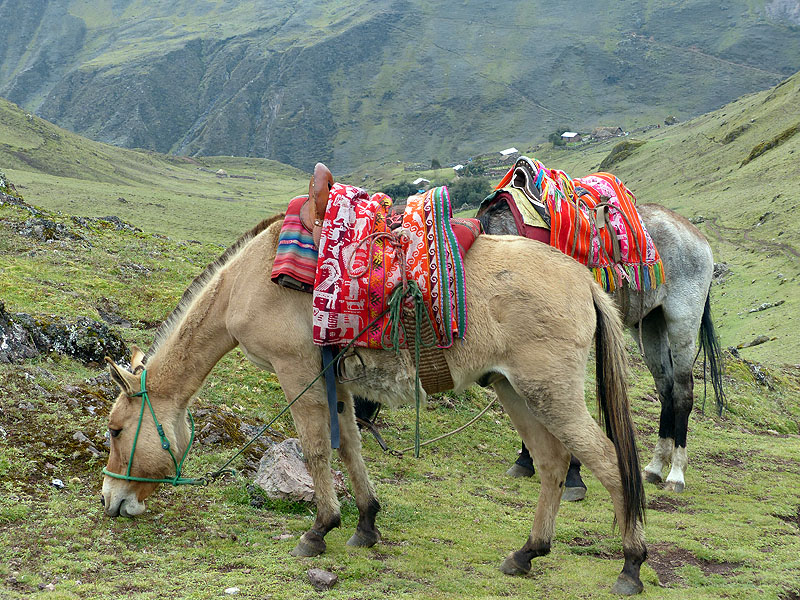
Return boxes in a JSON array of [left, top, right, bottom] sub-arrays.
[[102, 217, 647, 594]]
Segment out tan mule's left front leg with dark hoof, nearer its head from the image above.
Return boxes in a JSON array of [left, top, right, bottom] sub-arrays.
[[284, 398, 342, 556]]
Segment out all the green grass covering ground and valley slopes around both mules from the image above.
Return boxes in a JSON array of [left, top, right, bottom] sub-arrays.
[[0, 65, 800, 600]]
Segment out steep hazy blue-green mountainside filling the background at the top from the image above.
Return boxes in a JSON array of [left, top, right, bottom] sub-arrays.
[[0, 0, 800, 170]]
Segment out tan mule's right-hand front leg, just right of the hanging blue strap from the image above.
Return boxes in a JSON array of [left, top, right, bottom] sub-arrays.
[[339, 392, 381, 548]]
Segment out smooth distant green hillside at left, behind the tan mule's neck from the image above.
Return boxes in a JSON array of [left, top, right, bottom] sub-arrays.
[[0, 99, 308, 245]]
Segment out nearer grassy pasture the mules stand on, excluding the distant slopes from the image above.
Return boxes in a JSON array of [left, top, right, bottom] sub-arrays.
[[0, 189, 800, 600]]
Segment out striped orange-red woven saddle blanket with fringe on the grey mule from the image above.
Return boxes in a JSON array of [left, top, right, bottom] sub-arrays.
[[490, 157, 664, 292]]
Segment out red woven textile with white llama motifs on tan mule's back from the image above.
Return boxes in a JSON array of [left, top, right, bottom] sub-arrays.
[[313, 183, 466, 348]]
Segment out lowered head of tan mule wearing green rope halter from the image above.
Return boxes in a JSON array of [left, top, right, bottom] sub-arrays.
[[101, 348, 190, 517]]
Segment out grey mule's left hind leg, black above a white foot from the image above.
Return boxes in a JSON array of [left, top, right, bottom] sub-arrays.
[[641, 308, 675, 483]]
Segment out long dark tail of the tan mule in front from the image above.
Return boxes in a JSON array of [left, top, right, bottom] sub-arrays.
[[592, 285, 645, 527]]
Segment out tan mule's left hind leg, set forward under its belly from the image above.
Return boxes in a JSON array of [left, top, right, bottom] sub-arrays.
[[494, 380, 570, 575]]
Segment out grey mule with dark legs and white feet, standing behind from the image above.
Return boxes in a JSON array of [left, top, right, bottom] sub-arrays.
[[480, 202, 724, 492]]
